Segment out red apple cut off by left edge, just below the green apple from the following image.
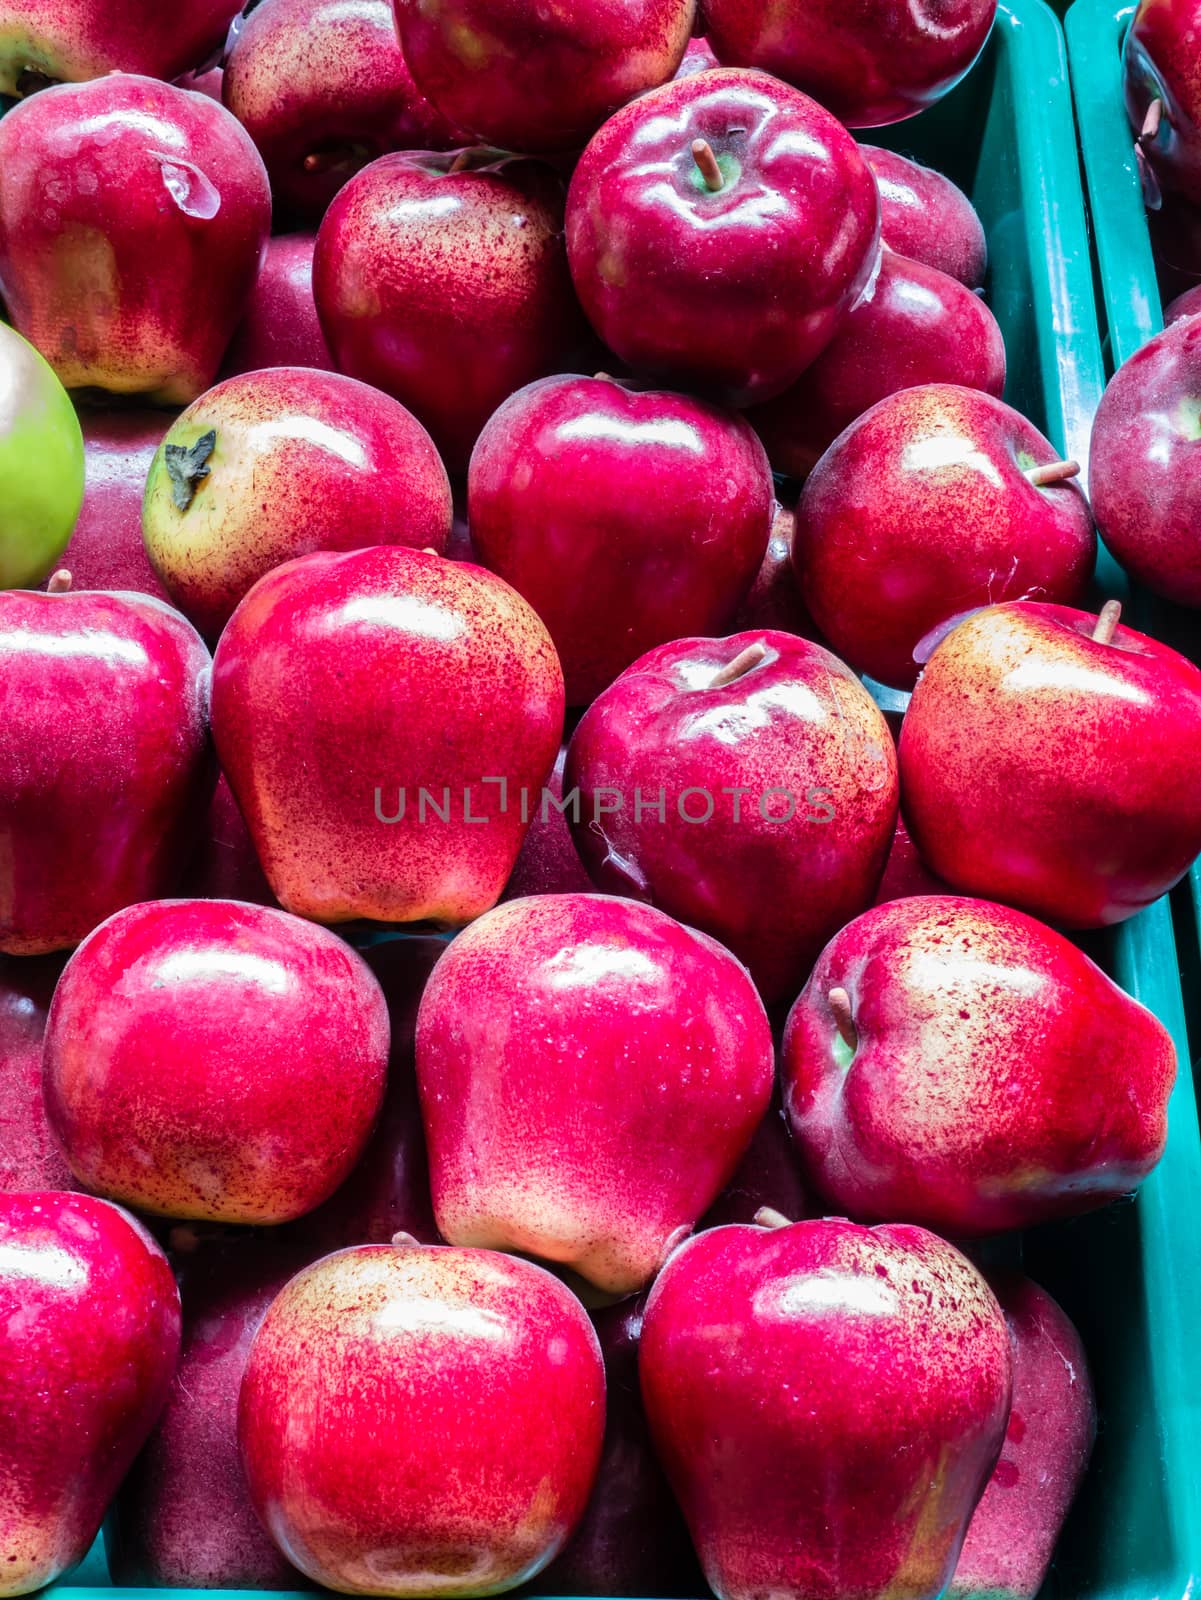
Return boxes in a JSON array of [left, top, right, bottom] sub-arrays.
[[0, 595, 213, 955]]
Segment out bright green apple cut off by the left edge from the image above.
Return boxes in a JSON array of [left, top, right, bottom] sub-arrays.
[[0, 323, 83, 589]]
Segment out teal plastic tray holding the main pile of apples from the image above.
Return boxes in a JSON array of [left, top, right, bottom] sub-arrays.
[[39, 0, 1201, 1600]]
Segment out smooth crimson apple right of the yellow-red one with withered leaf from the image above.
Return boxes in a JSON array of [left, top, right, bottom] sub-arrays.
[[467, 376, 776, 706]]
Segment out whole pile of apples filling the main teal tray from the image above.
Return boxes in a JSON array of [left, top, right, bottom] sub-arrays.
[[0, 0, 1201, 1600]]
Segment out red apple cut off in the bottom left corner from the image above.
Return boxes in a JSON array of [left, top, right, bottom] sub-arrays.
[[0, 1190, 179, 1595]]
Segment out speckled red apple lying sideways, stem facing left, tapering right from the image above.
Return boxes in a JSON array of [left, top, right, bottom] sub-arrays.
[[780, 894, 1175, 1238]]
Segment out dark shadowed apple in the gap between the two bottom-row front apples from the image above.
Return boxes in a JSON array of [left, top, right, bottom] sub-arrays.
[[531, 1298, 705, 1597]]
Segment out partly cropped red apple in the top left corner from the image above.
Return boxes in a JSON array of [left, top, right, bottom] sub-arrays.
[[0, 0, 238, 94]]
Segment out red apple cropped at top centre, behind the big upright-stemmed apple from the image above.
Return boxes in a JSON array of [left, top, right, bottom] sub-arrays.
[[395, 0, 696, 152]]
